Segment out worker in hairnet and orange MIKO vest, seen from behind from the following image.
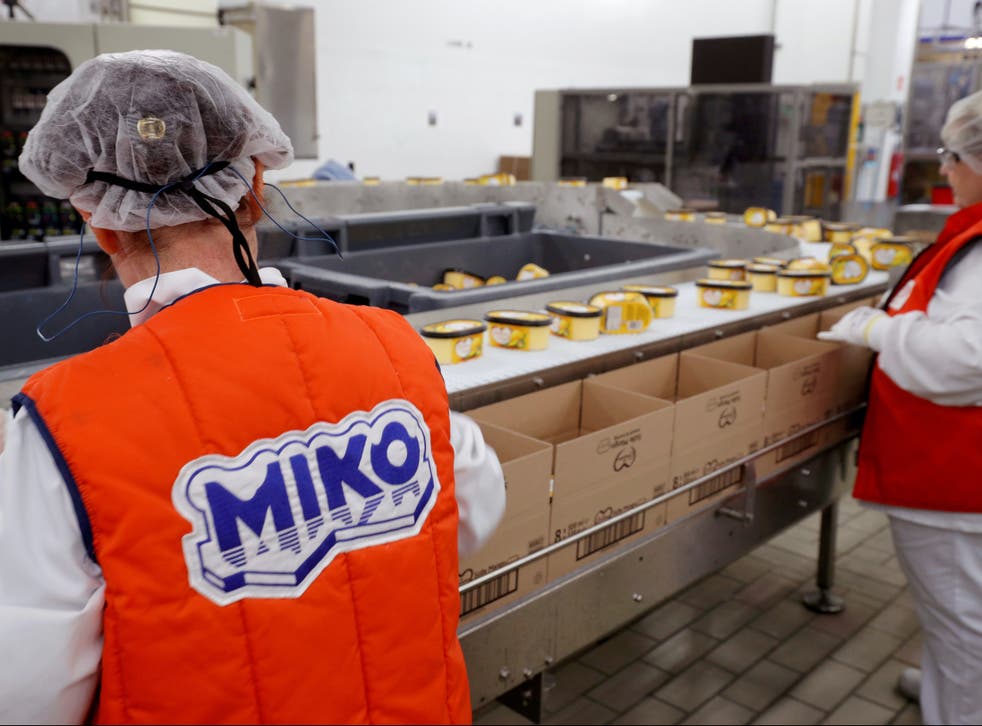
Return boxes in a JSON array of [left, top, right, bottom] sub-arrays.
[[0, 51, 504, 723]]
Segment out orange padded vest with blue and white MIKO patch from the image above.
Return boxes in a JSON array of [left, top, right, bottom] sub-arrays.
[[17, 285, 471, 723]]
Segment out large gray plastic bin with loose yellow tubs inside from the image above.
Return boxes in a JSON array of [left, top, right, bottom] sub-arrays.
[[279, 232, 719, 314]]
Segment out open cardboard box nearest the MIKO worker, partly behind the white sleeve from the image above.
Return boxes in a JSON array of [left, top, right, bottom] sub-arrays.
[[459, 422, 552, 622]]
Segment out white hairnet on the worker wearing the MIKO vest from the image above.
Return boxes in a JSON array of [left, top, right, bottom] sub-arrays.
[[19, 50, 293, 232]]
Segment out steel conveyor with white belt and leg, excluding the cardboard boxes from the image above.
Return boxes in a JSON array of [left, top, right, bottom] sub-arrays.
[[409, 269, 887, 720]]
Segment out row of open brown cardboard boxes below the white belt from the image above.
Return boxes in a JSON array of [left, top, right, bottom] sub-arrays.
[[461, 300, 871, 617]]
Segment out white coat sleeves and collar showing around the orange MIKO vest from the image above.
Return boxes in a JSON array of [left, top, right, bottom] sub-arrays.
[[0, 268, 505, 723]]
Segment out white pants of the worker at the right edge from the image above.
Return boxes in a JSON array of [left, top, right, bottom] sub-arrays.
[[890, 517, 982, 724]]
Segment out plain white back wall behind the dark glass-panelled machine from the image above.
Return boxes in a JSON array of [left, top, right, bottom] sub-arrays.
[[264, 0, 916, 179]]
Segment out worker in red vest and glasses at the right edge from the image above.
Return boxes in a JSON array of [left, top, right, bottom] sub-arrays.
[[821, 93, 982, 724]]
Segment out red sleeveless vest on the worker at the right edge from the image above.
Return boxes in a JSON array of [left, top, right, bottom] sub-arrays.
[[853, 210, 982, 512]]
